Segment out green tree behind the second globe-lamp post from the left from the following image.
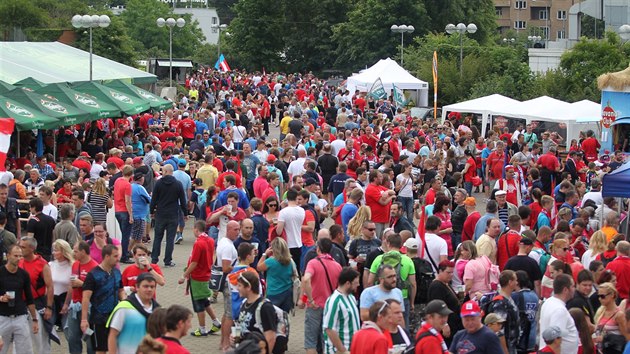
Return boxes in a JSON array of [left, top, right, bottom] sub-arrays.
[[120, 0, 205, 58]]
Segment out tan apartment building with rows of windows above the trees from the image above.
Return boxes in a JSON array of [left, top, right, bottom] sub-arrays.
[[494, 0, 580, 41]]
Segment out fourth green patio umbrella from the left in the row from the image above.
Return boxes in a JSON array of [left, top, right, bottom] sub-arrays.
[[71, 81, 151, 115]]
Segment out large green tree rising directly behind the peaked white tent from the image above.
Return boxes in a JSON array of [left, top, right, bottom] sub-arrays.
[[333, 0, 430, 71]]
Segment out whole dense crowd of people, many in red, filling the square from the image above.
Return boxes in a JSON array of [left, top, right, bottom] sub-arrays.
[[0, 70, 630, 354]]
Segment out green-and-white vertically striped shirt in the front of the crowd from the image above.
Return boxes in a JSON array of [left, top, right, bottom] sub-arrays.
[[322, 290, 361, 354]]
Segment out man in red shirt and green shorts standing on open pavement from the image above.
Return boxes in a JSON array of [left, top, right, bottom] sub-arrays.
[[178, 220, 220, 336]]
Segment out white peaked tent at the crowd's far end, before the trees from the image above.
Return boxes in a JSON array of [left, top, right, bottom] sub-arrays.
[[346, 58, 429, 106]]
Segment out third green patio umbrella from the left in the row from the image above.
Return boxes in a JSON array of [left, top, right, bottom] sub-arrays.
[[35, 83, 122, 120]]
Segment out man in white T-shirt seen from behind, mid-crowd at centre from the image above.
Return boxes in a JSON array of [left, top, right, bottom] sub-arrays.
[[276, 188, 305, 269]]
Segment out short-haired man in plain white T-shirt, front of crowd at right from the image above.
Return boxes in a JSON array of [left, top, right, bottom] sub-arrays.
[[539, 274, 579, 354]]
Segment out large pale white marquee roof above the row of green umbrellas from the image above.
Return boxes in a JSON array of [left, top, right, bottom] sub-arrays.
[[0, 42, 157, 84]]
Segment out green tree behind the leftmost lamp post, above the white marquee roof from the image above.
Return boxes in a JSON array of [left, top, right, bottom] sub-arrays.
[[74, 14, 138, 67]]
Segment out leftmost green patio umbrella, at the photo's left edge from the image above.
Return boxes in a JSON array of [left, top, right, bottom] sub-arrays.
[[0, 96, 59, 130]]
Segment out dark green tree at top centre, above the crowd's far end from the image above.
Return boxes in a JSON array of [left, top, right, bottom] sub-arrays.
[[221, 0, 286, 70]]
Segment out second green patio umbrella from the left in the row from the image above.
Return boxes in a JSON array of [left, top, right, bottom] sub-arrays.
[[2, 88, 90, 126]]
